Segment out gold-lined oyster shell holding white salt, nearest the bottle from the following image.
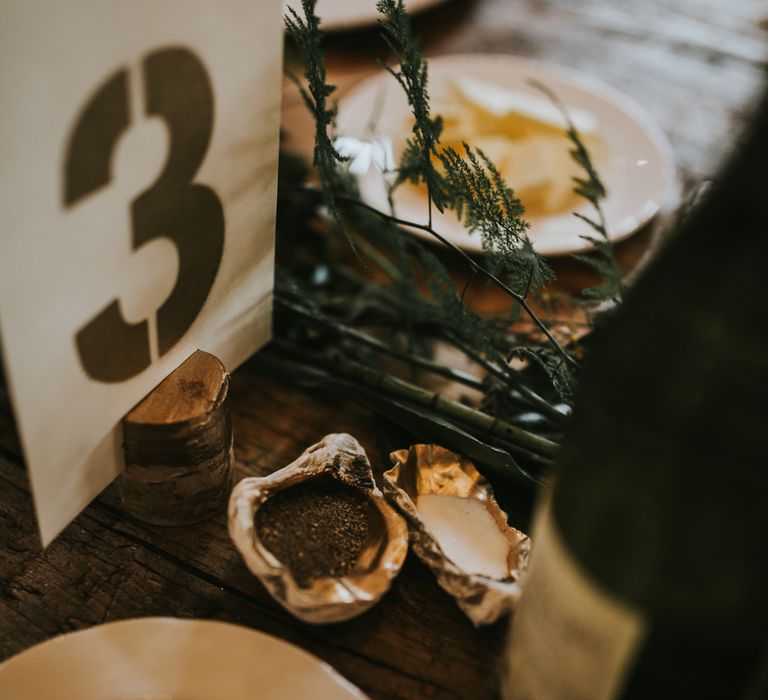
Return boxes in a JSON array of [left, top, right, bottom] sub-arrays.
[[384, 445, 531, 626]]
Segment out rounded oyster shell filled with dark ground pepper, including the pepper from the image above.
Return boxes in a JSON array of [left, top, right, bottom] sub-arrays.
[[229, 433, 408, 623]]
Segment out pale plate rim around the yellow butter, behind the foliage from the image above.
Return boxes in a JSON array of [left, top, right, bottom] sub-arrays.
[[338, 54, 677, 255]]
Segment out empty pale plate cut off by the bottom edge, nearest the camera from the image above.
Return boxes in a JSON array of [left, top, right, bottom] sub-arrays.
[[0, 617, 365, 700]]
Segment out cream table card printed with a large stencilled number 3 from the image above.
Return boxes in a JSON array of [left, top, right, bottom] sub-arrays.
[[0, 0, 282, 544]]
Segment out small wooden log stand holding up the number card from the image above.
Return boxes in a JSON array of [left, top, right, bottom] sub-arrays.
[[119, 350, 233, 525]]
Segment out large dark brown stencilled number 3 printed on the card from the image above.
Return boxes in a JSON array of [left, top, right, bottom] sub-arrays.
[[63, 48, 224, 382]]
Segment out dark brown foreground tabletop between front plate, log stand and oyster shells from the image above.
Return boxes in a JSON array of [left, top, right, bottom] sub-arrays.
[[0, 368, 504, 698]]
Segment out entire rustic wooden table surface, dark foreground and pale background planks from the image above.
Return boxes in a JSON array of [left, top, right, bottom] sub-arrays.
[[0, 0, 768, 699]]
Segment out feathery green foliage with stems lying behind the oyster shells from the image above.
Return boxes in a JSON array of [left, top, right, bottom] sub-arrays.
[[275, 0, 620, 490]]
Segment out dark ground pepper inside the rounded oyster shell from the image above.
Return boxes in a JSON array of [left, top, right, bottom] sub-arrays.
[[255, 477, 369, 586]]
